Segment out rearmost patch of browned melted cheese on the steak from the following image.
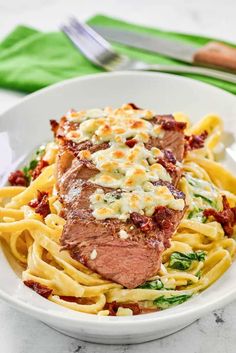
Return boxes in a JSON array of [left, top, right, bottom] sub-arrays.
[[66, 105, 163, 144]]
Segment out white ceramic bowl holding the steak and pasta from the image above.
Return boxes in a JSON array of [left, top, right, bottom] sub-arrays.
[[0, 72, 236, 344]]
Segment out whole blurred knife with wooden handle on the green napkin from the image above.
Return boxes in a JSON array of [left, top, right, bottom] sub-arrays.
[[92, 26, 236, 72]]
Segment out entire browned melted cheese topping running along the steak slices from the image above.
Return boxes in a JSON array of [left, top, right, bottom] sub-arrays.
[[64, 105, 184, 220]]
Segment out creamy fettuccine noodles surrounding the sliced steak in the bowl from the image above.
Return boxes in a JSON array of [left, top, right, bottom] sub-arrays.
[[0, 113, 236, 315]]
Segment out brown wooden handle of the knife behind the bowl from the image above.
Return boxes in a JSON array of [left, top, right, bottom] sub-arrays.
[[193, 42, 236, 72]]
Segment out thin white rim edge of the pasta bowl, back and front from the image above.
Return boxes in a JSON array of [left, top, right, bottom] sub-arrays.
[[0, 71, 236, 328]]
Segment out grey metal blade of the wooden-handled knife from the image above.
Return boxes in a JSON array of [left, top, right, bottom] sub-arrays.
[[91, 26, 198, 63]]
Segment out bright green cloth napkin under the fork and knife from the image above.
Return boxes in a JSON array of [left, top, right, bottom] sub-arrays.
[[0, 15, 236, 94]]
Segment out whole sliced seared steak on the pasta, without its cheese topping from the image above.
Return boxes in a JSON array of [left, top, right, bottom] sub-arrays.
[[54, 106, 185, 288]]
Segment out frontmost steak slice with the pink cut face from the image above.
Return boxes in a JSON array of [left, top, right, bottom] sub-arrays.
[[61, 211, 163, 288]]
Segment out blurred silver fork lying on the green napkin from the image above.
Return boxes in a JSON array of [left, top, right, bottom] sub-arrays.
[[61, 18, 236, 83]]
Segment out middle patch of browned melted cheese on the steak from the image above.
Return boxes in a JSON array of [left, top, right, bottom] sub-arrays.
[[90, 143, 171, 190]]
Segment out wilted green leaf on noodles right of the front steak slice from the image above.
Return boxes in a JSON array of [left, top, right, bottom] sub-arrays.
[[169, 251, 206, 271]]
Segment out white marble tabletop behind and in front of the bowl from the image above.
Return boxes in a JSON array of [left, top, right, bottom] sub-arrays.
[[0, 0, 236, 353]]
